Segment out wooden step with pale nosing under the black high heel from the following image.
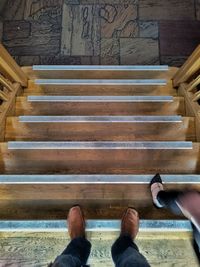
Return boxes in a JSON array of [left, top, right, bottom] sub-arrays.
[[0, 175, 200, 221]]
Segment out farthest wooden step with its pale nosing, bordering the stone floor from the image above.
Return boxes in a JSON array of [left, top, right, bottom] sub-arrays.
[[29, 65, 173, 79]]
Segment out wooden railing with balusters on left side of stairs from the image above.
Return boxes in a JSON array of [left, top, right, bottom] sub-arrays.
[[0, 44, 28, 141]]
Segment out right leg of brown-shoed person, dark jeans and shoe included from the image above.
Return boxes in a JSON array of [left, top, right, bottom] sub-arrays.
[[111, 208, 150, 267]]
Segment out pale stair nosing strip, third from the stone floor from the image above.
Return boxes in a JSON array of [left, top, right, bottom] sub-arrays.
[[27, 95, 174, 103]]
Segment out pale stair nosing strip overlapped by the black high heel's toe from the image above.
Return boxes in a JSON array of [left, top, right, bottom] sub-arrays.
[[0, 174, 200, 185]]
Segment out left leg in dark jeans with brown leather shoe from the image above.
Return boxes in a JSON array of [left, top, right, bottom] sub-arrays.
[[51, 206, 91, 267]]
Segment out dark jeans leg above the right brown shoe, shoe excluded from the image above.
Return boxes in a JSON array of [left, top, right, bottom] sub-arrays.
[[111, 236, 150, 267]]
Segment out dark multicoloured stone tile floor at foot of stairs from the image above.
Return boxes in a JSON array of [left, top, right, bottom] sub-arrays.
[[0, 0, 200, 66]]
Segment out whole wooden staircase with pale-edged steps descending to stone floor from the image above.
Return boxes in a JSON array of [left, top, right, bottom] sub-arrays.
[[0, 44, 200, 223]]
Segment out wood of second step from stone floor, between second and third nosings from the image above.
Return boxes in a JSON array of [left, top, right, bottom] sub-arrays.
[[24, 80, 177, 96]]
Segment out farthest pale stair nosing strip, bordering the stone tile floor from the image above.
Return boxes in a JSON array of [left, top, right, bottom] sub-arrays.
[[33, 65, 169, 71]]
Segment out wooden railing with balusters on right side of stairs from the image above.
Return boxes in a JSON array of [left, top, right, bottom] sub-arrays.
[[173, 45, 200, 141]]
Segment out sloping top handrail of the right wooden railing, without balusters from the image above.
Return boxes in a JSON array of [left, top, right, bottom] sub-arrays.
[[173, 45, 200, 87]]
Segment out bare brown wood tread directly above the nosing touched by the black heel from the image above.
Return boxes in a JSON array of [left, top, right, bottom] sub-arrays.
[[0, 143, 200, 174]]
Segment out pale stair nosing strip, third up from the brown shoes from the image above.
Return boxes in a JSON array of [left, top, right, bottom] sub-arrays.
[[8, 141, 192, 150]]
